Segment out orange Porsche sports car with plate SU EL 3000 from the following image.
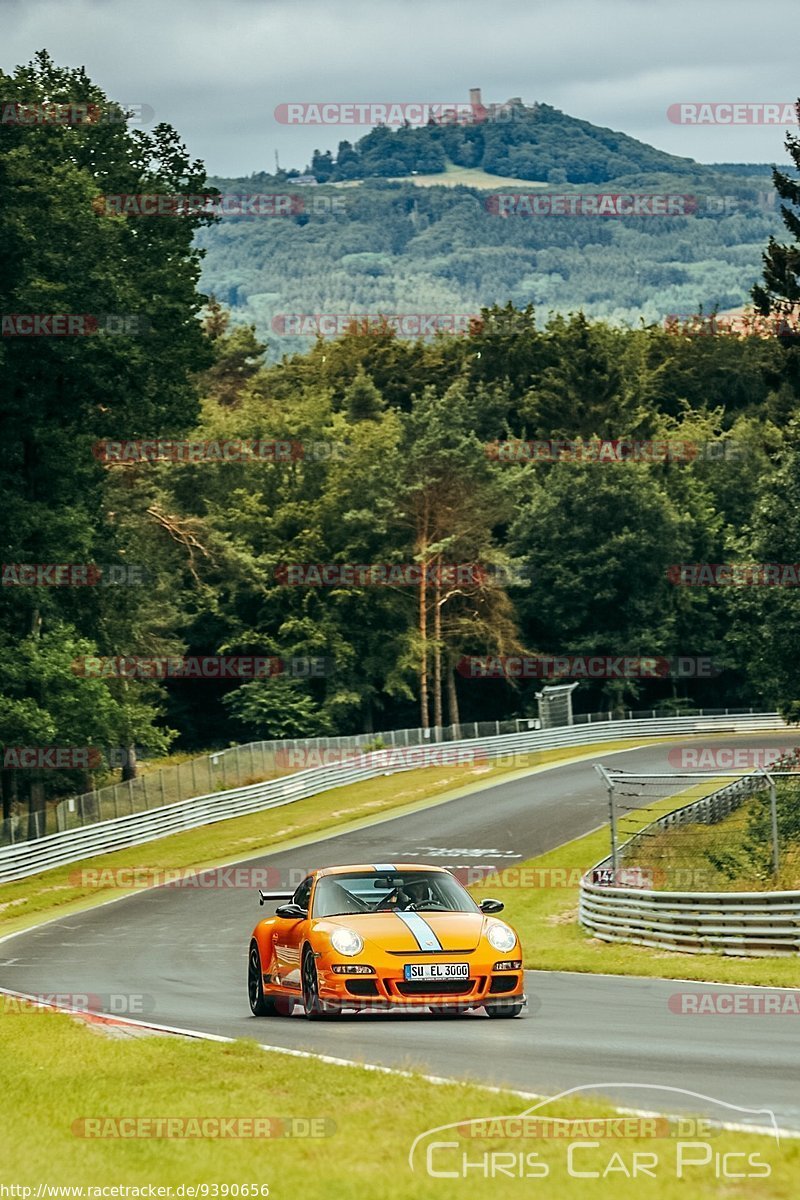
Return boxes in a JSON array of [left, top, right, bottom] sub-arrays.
[[247, 863, 525, 1019]]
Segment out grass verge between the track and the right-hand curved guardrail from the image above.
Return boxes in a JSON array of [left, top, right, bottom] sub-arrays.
[[482, 780, 798, 988]]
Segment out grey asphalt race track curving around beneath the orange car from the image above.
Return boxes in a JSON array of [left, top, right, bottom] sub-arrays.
[[0, 732, 800, 1130]]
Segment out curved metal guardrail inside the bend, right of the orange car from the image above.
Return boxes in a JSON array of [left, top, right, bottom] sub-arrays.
[[578, 775, 800, 958]]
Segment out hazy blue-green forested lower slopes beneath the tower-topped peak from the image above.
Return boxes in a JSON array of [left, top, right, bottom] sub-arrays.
[[198, 175, 781, 361]]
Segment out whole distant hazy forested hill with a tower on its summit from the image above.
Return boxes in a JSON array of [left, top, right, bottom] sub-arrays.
[[198, 104, 781, 360]]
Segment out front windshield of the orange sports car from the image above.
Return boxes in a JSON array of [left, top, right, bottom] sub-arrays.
[[313, 871, 480, 917]]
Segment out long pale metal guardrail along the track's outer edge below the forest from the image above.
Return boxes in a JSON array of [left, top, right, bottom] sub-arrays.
[[0, 713, 784, 882]]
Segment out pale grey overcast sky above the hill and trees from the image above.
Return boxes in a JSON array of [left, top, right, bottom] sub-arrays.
[[0, 0, 800, 175]]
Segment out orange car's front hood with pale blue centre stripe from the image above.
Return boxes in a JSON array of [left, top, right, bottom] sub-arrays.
[[314, 910, 486, 954]]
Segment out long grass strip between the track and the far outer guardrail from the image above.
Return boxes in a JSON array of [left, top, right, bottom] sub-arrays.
[[0, 739, 667, 936]]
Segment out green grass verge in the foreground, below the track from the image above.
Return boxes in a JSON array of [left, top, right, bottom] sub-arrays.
[[0, 1012, 800, 1200]]
